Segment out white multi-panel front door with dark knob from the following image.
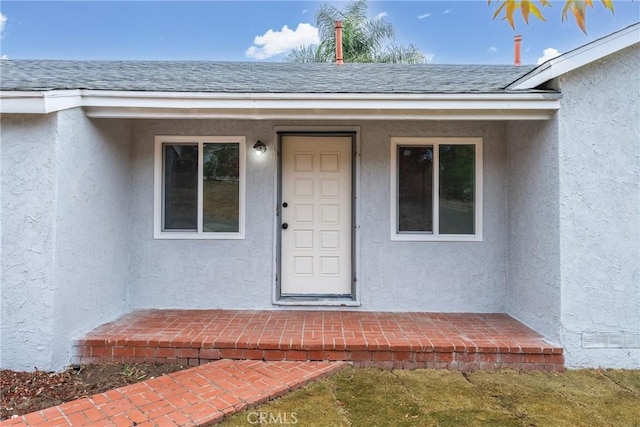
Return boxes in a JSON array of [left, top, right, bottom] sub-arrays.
[[280, 136, 352, 296]]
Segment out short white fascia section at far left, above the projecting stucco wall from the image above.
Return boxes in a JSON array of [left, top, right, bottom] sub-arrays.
[[0, 90, 82, 114]]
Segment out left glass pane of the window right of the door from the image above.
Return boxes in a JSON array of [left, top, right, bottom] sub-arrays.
[[398, 146, 433, 232]]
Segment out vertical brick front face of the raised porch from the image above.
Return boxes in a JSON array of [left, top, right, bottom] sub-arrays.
[[74, 340, 564, 372]]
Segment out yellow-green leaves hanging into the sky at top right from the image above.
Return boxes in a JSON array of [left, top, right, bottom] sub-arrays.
[[487, 0, 613, 34]]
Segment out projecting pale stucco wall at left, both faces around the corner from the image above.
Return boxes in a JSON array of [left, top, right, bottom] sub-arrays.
[[0, 109, 131, 370]]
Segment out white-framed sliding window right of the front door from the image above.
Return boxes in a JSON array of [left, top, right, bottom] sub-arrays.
[[391, 138, 482, 241]]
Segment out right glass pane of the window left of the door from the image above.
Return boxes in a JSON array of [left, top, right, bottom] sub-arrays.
[[202, 143, 240, 232]]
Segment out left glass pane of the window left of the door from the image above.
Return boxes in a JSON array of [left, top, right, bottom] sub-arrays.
[[163, 144, 198, 230]]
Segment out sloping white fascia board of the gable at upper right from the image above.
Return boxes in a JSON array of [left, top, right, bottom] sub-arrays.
[[507, 23, 640, 90]]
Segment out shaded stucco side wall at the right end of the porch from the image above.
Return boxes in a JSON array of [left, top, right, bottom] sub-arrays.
[[506, 116, 561, 342]]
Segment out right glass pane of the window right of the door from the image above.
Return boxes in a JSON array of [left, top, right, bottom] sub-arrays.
[[439, 145, 476, 234]]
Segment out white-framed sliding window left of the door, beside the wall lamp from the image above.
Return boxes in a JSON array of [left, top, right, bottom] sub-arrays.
[[154, 136, 246, 239]]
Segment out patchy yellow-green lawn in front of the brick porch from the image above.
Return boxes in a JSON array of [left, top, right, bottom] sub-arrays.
[[221, 368, 640, 427]]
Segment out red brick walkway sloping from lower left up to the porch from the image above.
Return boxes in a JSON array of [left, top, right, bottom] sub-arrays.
[[0, 360, 346, 427]]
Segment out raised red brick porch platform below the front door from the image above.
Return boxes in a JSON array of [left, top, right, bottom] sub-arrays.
[[73, 310, 564, 371]]
